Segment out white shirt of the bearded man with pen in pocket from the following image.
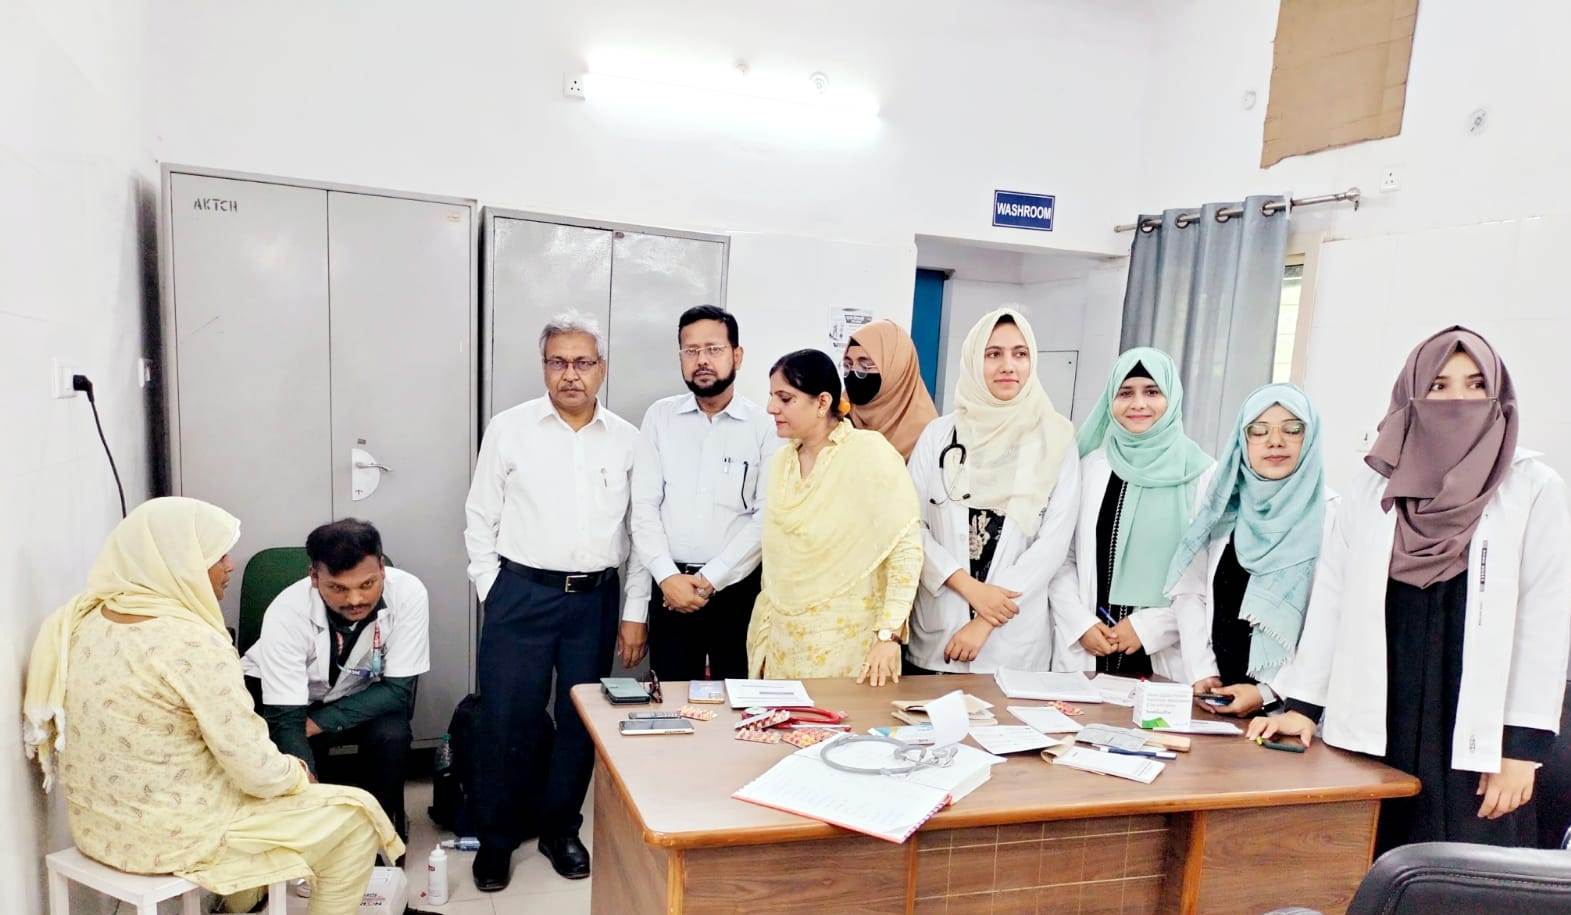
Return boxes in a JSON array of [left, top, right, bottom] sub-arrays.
[[624, 393, 781, 623]]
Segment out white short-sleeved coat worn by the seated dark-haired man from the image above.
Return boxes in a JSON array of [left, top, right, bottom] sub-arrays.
[[240, 566, 430, 706]]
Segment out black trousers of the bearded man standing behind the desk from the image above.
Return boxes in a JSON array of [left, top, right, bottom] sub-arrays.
[[649, 569, 764, 681]]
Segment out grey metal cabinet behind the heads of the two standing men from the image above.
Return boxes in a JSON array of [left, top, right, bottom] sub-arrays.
[[481, 208, 727, 424]]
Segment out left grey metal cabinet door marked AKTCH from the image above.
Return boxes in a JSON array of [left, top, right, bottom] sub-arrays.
[[165, 173, 331, 623]]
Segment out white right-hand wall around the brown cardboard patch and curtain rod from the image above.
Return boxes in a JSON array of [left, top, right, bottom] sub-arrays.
[[1141, 0, 1571, 484]]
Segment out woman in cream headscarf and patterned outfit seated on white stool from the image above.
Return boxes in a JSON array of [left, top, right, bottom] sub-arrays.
[[24, 498, 404, 915]]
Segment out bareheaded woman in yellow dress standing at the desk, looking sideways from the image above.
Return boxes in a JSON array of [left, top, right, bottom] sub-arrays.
[[748, 349, 922, 685]]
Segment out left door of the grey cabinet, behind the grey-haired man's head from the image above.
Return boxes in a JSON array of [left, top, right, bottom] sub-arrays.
[[482, 215, 611, 420]]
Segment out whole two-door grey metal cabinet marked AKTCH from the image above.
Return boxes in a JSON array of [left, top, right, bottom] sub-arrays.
[[162, 167, 479, 742]]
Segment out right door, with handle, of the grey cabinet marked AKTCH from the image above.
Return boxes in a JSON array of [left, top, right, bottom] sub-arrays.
[[324, 192, 476, 740]]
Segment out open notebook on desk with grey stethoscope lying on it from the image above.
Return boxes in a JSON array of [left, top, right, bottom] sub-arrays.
[[732, 744, 1004, 843]]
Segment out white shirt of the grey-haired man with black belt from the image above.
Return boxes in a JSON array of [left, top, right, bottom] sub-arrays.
[[463, 398, 643, 601]]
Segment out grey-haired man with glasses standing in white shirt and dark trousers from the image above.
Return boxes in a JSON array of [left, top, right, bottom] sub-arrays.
[[463, 313, 643, 893]]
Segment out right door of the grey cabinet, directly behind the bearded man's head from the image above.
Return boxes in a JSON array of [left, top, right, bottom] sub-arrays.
[[605, 231, 726, 426]]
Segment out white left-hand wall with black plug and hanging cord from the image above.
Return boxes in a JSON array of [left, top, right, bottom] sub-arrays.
[[0, 0, 154, 913]]
